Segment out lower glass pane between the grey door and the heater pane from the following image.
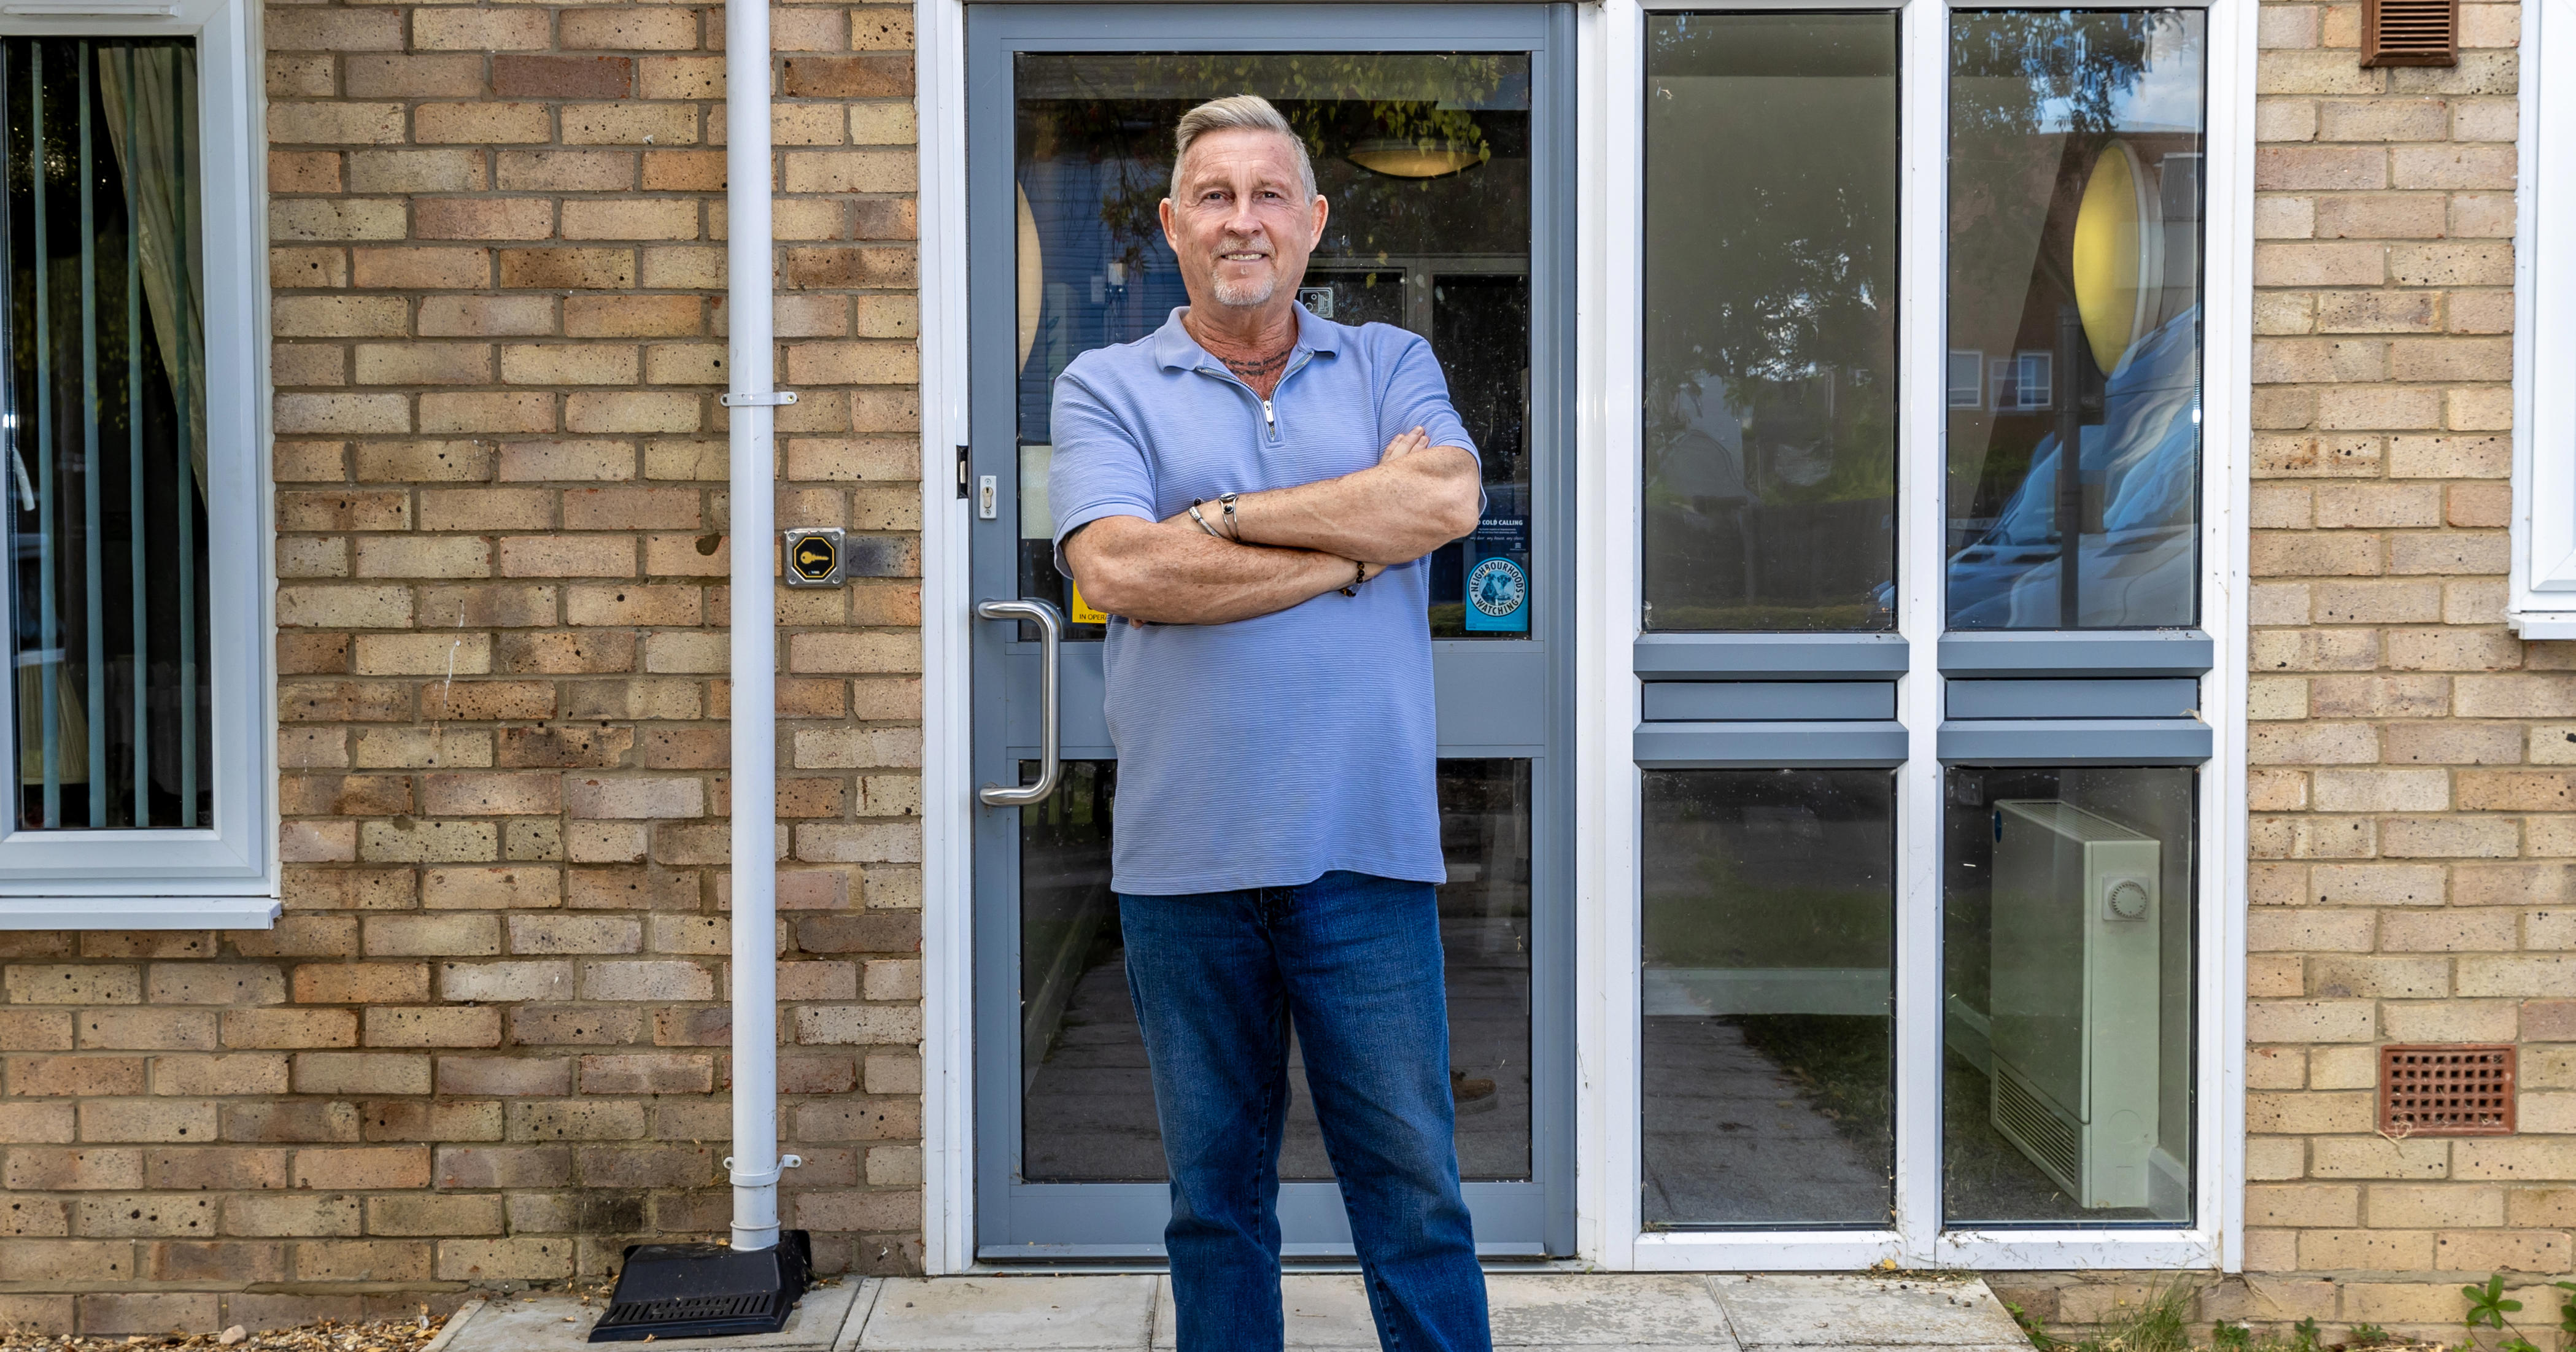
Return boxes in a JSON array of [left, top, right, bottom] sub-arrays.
[[1641, 770, 1896, 1229]]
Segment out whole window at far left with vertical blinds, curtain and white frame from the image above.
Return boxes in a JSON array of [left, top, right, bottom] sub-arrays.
[[0, 2, 276, 927]]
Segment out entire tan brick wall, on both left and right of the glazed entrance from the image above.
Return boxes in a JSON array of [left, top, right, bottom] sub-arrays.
[[0, 2, 2576, 1337]]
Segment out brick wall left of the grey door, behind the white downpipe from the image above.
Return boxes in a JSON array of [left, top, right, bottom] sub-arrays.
[[0, 0, 919, 1331]]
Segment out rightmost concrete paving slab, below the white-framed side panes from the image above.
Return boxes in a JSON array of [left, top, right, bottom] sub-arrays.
[[1708, 1275, 2027, 1350]]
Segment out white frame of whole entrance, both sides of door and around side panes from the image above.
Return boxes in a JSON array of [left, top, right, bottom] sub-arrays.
[[915, 0, 2246, 1272]]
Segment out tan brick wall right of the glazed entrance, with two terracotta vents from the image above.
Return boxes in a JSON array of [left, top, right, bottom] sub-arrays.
[[1999, 2, 2545, 1342]]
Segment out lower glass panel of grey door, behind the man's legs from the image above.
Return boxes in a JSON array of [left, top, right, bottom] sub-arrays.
[[1020, 760, 1530, 1182]]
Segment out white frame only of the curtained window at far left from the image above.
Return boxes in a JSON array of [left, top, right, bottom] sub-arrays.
[[0, 0, 278, 930]]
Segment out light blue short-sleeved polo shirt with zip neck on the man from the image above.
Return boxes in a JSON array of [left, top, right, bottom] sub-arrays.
[[1046, 306, 1476, 896]]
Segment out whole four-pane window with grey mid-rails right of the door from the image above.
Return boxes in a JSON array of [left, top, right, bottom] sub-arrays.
[[1605, 0, 2251, 1270]]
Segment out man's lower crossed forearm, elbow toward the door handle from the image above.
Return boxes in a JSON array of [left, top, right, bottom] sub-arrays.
[[1064, 517, 1375, 623]]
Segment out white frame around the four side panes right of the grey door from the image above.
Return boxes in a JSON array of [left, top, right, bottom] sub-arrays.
[[1577, 0, 2246, 1272]]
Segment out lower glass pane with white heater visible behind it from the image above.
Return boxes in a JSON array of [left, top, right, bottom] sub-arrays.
[[1943, 765, 2197, 1226]]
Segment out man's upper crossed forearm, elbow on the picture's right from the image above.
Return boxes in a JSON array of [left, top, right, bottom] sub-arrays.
[[1237, 446, 1483, 566]]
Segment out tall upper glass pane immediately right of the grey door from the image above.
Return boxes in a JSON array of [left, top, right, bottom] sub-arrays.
[[1644, 13, 1896, 631]]
